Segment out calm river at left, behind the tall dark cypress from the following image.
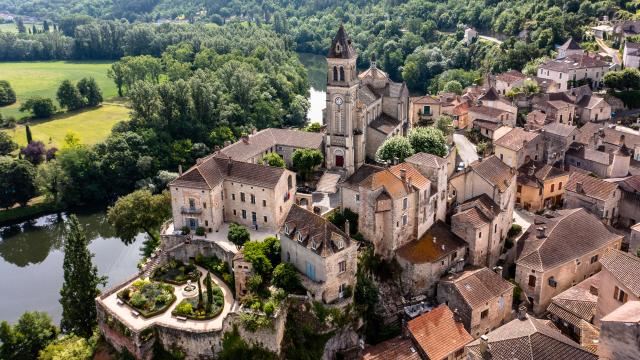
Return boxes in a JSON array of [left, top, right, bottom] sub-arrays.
[[0, 212, 145, 323]]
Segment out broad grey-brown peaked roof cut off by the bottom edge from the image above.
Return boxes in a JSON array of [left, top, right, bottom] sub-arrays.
[[467, 316, 598, 360]]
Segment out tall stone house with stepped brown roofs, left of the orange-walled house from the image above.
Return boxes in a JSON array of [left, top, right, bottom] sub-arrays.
[[449, 156, 517, 267]]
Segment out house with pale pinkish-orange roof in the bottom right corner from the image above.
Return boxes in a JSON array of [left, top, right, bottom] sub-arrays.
[[598, 301, 640, 360]]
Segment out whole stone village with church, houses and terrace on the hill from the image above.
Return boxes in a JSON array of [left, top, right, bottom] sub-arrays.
[[90, 22, 640, 360]]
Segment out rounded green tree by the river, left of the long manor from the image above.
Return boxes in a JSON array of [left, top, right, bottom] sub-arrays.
[[107, 189, 171, 244]]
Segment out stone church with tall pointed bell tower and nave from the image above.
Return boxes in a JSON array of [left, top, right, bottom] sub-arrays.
[[324, 25, 409, 176]]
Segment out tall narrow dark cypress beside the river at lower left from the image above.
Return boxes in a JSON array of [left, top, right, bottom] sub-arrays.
[[60, 215, 106, 338]]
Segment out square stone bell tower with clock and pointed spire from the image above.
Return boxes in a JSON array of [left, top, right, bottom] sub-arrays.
[[325, 25, 363, 175]]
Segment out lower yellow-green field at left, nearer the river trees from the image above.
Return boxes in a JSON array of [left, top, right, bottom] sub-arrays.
[[2, 104, 129, 148]]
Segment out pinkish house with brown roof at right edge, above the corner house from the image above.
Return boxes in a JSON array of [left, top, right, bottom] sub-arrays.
[[595, 249, 640, 325]]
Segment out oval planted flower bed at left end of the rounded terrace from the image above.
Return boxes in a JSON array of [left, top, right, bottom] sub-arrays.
[[118, 280, 176, 318]]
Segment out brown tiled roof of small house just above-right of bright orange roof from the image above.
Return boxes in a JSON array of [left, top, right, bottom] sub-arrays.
[[440, 268, 515, 309]]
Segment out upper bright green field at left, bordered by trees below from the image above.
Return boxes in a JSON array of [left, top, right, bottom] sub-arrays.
[[0, 60, 117, 119]]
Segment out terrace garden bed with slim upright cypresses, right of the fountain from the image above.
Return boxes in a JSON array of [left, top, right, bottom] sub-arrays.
[[171, 273, 224, 320]]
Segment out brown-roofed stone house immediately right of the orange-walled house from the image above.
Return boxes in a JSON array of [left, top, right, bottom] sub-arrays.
[[564, 171, 621, 225]]
